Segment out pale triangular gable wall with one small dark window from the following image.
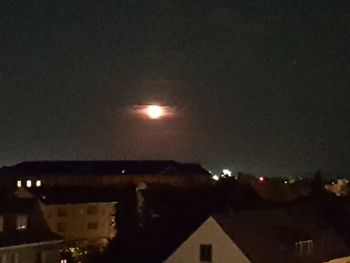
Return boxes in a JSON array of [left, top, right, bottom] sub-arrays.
[[164, 217, 250, 263]]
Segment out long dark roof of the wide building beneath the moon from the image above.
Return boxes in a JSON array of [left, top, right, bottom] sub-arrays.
[[0, 160, 209, 175]]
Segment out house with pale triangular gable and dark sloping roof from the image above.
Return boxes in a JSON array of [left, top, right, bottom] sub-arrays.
[[163, 207, 350, 263]]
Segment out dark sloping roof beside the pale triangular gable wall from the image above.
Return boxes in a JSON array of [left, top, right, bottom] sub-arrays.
[[214, 206, 350, 263]]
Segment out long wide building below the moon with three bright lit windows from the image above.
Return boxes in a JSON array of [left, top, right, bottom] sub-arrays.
[[0, 160, 211, 188]]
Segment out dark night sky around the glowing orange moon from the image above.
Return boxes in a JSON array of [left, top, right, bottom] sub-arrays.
[[0, 0, 350, 177]]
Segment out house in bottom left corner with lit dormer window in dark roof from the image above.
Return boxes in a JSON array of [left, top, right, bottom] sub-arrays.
[[0, 197, 62, 263]]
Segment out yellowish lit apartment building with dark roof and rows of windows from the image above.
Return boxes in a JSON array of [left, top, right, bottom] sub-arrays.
[[32, 189, 117, 249]]
